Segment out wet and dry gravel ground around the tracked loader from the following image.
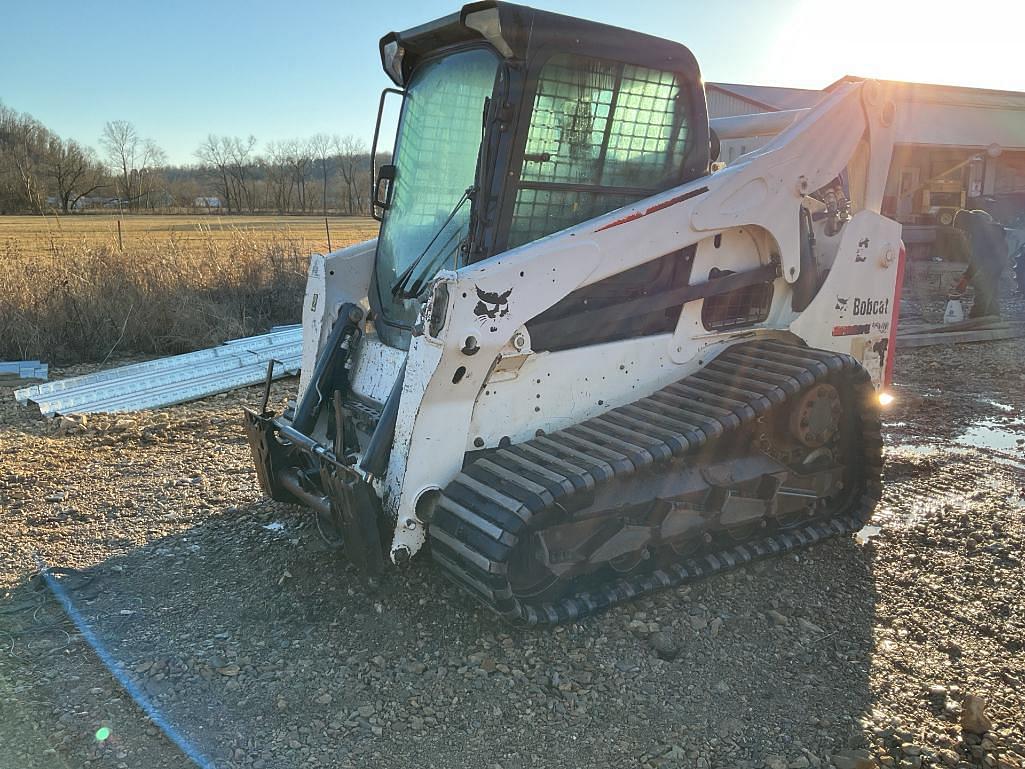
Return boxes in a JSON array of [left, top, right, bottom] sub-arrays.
[[0, 330, 1025, 769]]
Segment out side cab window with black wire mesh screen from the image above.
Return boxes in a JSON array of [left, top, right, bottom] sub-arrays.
[[508, 54, 688, 247]]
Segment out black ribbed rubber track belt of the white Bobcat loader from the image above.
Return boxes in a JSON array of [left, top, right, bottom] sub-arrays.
[[429, 340, 883, 624]]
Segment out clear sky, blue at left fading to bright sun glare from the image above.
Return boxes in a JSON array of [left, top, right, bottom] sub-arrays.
[[0, 0, 1025, 163]]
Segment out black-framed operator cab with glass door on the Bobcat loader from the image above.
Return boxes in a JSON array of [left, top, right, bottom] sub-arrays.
[[370, 2, 709, 349]]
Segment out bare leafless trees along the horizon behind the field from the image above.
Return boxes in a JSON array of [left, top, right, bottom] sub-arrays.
[[0, 102, 371, 215]]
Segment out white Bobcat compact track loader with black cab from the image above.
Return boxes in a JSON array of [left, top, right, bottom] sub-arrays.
[[246, 2, 903, 623]]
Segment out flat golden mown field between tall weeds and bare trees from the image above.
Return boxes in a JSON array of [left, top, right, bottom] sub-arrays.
[[0, 213, 377, 257]]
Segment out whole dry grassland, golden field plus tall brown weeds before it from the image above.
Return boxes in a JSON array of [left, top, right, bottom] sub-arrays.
[[0, 215, 377, 364]]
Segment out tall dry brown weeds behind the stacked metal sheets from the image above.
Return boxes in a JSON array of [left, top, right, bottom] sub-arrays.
[[0, 231, 309, 364]]
